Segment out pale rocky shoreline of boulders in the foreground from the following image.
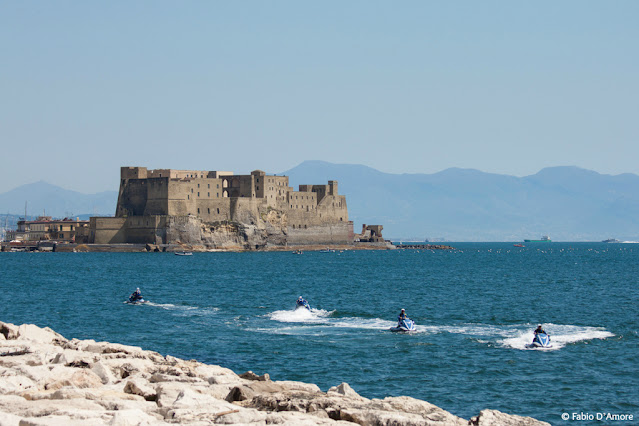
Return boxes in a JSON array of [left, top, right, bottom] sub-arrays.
[[0, 322, 548, 426]]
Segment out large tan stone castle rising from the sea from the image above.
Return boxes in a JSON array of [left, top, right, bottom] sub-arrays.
[[89, 167, 354, 249]]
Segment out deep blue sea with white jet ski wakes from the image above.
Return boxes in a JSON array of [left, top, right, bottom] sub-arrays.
[[0, 242, 639, 424]]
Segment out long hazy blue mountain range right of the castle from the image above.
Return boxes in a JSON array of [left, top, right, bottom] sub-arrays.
[[283, 161, 639, 241]]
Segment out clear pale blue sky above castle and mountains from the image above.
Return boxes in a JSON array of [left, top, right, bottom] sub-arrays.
[[0, 0, 639, 193]]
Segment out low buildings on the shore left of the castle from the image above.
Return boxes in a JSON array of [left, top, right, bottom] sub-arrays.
[[5, 216, 89, 242]]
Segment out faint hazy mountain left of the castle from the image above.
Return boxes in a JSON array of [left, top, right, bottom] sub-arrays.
[[0, 181, 118, 217]]
